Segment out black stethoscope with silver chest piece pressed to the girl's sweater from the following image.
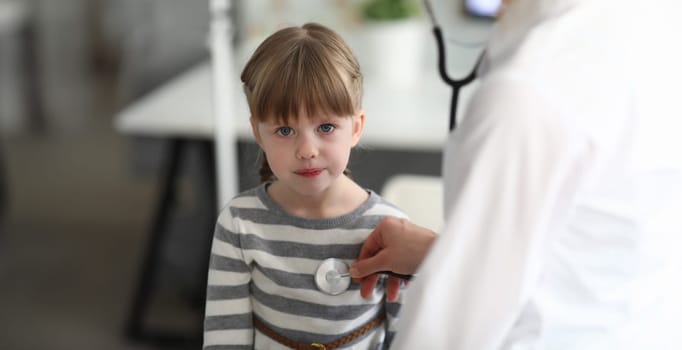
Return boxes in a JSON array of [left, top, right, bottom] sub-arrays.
[[315, 0, 483, 295]]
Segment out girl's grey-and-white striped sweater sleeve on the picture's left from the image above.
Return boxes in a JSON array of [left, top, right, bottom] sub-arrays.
[[203, 207, 254, 350]]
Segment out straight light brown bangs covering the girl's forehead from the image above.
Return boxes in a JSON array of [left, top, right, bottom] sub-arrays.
[[244, 32, 362, 123]]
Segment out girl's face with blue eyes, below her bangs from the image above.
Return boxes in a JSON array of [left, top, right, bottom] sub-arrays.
[[251, 111, 365, 196]]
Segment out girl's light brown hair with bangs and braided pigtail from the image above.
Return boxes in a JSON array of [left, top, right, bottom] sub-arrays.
[[241, 23, 362, 181]]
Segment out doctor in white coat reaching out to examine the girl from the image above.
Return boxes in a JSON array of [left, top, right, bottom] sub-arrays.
[[351, 0, 682, 350]]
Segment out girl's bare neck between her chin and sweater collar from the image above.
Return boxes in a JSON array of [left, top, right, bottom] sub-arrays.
[[267, 176, 369, 219]]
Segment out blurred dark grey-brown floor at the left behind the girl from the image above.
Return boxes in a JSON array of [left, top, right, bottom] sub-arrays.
[[0, 75, 200, 350]]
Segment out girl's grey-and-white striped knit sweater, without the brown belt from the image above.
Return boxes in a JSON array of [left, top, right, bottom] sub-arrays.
[[204, 184, 405, 350]]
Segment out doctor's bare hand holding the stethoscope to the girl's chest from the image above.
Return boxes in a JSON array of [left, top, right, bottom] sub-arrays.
[[349, 217, 436, 301]]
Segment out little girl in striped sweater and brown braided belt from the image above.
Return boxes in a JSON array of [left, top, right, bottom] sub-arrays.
[[204, 24, 405, 349]]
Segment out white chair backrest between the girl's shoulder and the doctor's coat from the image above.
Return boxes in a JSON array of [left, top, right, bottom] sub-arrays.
[[381, 174, 443, 232]]
